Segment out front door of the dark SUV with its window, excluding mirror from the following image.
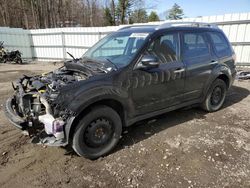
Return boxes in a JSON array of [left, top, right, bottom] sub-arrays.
[[132, 33, 185, 115]]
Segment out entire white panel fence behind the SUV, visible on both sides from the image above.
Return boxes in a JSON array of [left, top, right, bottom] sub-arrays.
[[0, 13, 250, 66]]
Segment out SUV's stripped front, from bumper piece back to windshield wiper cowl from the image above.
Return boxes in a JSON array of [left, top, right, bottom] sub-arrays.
[[6, 59, 115, 146]]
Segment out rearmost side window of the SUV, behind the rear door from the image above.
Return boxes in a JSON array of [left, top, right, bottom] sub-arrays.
[[208, 32, 231, 57]]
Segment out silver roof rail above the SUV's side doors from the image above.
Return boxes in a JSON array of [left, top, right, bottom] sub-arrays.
[[156, 22, 218, 29]]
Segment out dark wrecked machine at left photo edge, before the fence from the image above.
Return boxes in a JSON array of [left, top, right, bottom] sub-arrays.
[[0, 42, 22, 64]]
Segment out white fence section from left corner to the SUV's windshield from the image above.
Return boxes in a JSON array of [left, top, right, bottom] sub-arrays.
[[30, 26, 120, 60]]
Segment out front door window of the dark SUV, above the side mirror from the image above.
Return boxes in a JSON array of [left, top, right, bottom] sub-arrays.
[[147, 33, 179, 63]]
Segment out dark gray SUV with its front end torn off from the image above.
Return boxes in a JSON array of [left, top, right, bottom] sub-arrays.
[[5, 22, 236, 159]]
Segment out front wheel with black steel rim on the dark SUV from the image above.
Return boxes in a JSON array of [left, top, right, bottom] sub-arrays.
[[72, 106, 122, 159]]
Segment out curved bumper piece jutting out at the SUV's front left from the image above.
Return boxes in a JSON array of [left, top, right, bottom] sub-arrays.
[[4, 97, 27, 130]]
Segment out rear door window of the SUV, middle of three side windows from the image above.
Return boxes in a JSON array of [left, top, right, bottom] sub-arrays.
[[183, 33, 210, 59]]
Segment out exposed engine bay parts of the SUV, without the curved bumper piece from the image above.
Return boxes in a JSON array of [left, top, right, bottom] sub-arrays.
[[13, 67, 87, 143]]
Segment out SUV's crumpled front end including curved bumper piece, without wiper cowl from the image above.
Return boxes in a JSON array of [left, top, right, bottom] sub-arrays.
[[5, 68, 86, 146]]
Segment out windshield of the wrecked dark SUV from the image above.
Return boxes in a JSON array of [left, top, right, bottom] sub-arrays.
[[83, 32, 149, 67]]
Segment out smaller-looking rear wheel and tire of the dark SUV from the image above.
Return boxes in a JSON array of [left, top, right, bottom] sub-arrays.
[[201, 79, 227, 112]]
